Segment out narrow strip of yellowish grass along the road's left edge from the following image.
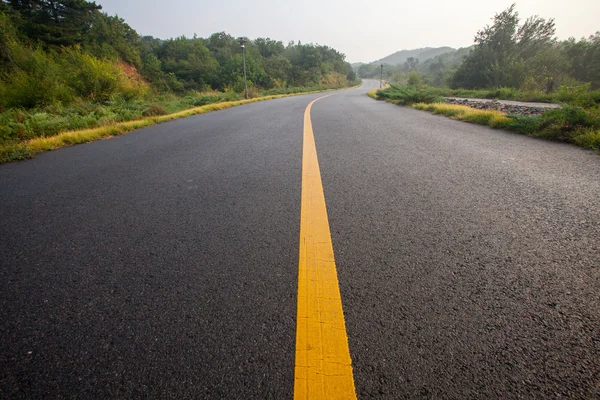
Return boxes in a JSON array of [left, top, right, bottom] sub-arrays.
[[0, 89, 335, 164]]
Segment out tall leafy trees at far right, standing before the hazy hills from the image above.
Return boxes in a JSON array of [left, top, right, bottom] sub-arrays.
[[450, 4, 600, 93]]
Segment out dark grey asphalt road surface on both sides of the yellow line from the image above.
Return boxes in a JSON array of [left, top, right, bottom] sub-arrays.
[[0, 81, 600, 399]]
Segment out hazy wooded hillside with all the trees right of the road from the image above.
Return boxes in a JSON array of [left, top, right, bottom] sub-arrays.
[[358, 4, 600, 94]]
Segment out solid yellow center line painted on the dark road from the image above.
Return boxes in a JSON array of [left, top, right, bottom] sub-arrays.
[[294, 95, 356, 400]]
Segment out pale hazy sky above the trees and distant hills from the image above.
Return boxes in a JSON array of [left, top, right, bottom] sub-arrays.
[[96, 0, 600, 62]]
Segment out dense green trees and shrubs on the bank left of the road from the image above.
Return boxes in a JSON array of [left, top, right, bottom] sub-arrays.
[[0, 0, 356, 108]]
